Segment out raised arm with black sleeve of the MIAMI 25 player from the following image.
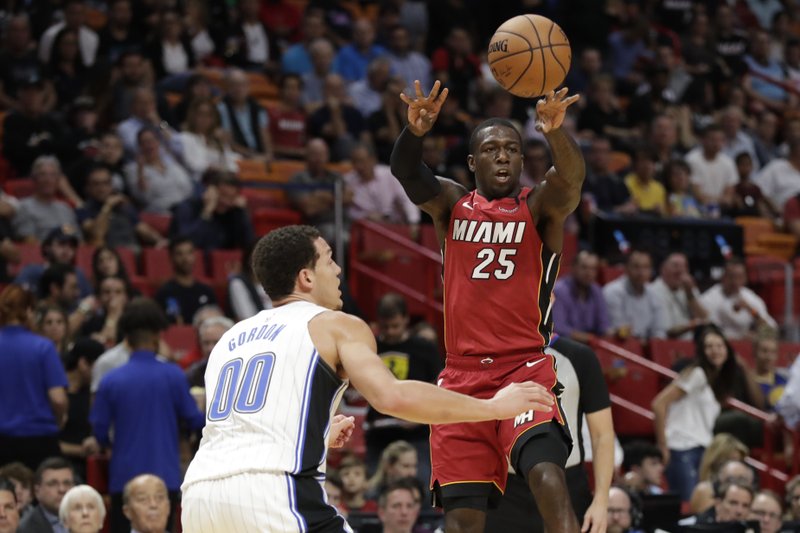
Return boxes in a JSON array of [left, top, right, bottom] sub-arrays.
[[390, 80, 466, 213]]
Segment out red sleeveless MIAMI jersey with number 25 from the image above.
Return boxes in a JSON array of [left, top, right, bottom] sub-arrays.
[[443, 187, 560, 357]]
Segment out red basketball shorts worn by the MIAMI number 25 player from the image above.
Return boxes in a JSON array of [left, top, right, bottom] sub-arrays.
[[431, 352, 566, 497]]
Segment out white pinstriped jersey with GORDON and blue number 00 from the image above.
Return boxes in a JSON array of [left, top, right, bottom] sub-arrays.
[[183, 302, 348, 487]]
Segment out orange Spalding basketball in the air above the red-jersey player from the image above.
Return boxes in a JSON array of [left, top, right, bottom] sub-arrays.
[[487, 15, 572, 98]]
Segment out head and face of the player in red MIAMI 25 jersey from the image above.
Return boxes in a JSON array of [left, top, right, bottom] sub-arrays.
[[467, 125, 522, 200]]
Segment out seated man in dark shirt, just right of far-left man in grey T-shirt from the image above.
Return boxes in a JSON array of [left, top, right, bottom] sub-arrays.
[[76, 166, 166, 250]]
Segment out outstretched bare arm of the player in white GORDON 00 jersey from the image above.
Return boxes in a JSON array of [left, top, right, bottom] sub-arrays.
[[330, 313, 554, 424]]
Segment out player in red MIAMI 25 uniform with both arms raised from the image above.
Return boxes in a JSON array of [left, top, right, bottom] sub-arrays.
[[391, 81, 588, 533]]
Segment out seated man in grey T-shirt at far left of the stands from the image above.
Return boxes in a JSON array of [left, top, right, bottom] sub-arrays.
[[14, 156, 78, 242]]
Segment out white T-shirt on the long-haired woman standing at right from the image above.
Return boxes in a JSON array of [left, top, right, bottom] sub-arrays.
[[665, 367, 720, 451]]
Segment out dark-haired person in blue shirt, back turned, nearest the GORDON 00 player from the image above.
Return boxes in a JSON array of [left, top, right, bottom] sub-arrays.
[[91, 298, 205, 531]]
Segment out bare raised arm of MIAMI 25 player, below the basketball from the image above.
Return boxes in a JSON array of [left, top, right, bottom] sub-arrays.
[[529, 87, 586, 251]]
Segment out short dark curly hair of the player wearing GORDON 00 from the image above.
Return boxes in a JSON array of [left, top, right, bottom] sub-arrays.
[[251, 225, 320, 301]]
